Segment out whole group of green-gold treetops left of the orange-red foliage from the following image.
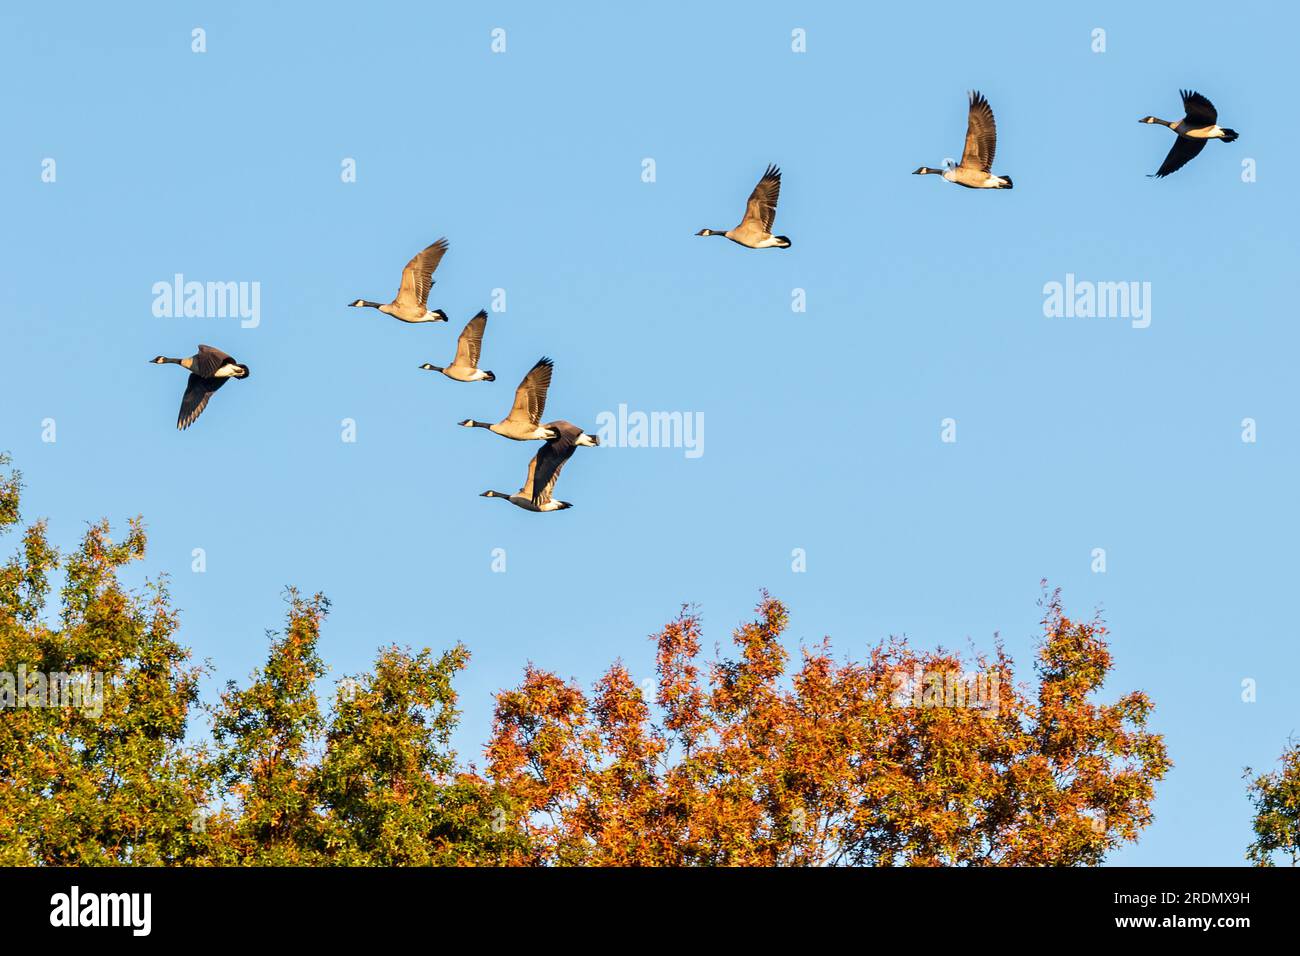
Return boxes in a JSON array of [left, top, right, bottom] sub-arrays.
[[0, 457, 523, 865]]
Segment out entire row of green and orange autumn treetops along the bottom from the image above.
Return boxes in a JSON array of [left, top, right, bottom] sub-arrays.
[[0, 457, 1175, 866]]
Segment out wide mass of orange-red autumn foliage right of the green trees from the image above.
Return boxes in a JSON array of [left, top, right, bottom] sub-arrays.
[[488, 593, 1170, 866]]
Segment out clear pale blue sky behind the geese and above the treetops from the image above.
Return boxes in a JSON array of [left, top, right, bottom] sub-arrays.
[[0, 3, 1300, 865]]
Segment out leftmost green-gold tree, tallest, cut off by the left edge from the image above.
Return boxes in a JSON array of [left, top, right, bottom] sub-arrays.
[[0, 459, 211, 865]]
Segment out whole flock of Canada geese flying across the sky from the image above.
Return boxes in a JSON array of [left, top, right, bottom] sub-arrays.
[[151, 90, 1238, 511]]
